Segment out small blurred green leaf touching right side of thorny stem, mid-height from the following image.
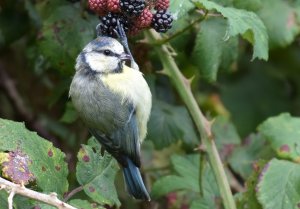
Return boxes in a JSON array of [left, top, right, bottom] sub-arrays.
[[212, 116, 241, 153]]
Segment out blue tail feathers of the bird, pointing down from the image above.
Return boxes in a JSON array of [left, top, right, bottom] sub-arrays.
[[123, 158, 150, 201]]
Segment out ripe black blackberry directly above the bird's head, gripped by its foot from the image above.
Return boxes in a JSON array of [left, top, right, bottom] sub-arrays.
[[99, 12, 130, 38]]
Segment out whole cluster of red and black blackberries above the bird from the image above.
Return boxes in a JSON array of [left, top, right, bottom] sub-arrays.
[[88, 0, 173, 37]]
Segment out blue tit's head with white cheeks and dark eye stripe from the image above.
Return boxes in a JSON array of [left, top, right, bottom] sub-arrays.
[[76, 37, 130, 74]]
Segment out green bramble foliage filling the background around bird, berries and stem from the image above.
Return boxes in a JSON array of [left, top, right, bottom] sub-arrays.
[[0, 0, 300, 209]]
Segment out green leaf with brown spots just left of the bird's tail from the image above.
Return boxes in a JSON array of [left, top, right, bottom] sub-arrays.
[[76, 138, 120, 206]]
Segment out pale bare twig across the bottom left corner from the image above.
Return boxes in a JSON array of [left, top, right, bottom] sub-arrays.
[[0, 177, 77, 209]]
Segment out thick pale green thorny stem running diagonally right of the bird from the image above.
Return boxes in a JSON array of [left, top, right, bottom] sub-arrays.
[[145, 30, 236, 209]]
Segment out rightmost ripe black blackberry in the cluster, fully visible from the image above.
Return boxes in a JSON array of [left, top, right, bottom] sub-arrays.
[[151, 10, 173, 33]]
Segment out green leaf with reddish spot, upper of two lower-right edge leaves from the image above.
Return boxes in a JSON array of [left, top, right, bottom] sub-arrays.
[[258, 113, 300, 163]]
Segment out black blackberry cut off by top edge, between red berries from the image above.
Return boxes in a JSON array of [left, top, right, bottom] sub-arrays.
[[120, 0, 146, 17]]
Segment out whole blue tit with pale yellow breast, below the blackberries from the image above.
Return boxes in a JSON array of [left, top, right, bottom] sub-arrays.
[[69, 37, 152, 201]]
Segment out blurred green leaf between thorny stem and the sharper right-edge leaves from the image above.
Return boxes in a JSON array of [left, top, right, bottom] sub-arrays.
[[229, 134, 274, 179]]
